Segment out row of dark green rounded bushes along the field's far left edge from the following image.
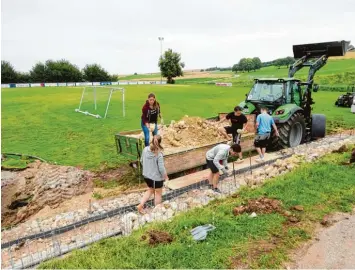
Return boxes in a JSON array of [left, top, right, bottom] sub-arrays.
[[1, 59, 118, 84]]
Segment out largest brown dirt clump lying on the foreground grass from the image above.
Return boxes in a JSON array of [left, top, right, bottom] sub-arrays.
[[233, 197, 281, 216]]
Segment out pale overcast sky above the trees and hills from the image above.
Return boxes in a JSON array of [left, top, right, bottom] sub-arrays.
[[1, 0, 355, 74]]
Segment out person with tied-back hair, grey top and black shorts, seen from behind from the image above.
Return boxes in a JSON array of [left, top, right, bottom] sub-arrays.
[[137, 135, 169, 214]]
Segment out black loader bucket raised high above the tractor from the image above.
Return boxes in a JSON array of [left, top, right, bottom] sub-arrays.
[[293, 40, 350, 59]]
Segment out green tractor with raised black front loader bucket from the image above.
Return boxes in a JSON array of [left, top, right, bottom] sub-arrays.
[[239, 40, 350, 148]]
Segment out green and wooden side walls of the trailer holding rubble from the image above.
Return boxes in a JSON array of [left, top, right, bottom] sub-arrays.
[[115, 113, 255, 178]]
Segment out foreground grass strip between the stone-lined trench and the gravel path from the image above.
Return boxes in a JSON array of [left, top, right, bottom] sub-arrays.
[[39, 152, 355, 269]]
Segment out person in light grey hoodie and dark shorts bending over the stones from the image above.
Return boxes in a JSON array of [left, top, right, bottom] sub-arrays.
[[206, 144, 242, 192]]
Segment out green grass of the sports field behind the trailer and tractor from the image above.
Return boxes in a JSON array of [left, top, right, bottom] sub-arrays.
[[1, 85, 355, 170]]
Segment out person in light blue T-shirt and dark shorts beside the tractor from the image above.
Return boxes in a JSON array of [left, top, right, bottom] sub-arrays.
[[254, 107, 279, 162]]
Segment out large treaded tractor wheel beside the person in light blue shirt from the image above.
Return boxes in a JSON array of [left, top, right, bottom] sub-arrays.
[[277, 113, 306, 148]]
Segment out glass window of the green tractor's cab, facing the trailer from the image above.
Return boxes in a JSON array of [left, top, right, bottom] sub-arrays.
[[247, 82, 285, 102]]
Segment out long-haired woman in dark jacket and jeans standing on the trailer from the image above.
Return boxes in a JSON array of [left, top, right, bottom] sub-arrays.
[[141, 93, 161, 146]]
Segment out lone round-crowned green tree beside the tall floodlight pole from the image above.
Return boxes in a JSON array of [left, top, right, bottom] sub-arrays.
[[158, 49, 185, 83]]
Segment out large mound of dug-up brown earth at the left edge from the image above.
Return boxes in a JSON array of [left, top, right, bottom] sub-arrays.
[[1, 161, 91, 226]]
